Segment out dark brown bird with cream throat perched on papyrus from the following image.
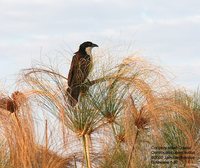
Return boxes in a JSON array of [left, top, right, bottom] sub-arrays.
[[67, 41, 98, 106]]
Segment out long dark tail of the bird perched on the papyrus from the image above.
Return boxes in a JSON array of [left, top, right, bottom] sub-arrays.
[[67, 86, 81, 107]]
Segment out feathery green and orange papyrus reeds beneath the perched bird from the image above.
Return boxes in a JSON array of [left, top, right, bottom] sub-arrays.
[[0, 54, 200, 168]]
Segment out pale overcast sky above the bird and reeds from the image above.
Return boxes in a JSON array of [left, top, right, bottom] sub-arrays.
[[0, 0, 200, 89]]
